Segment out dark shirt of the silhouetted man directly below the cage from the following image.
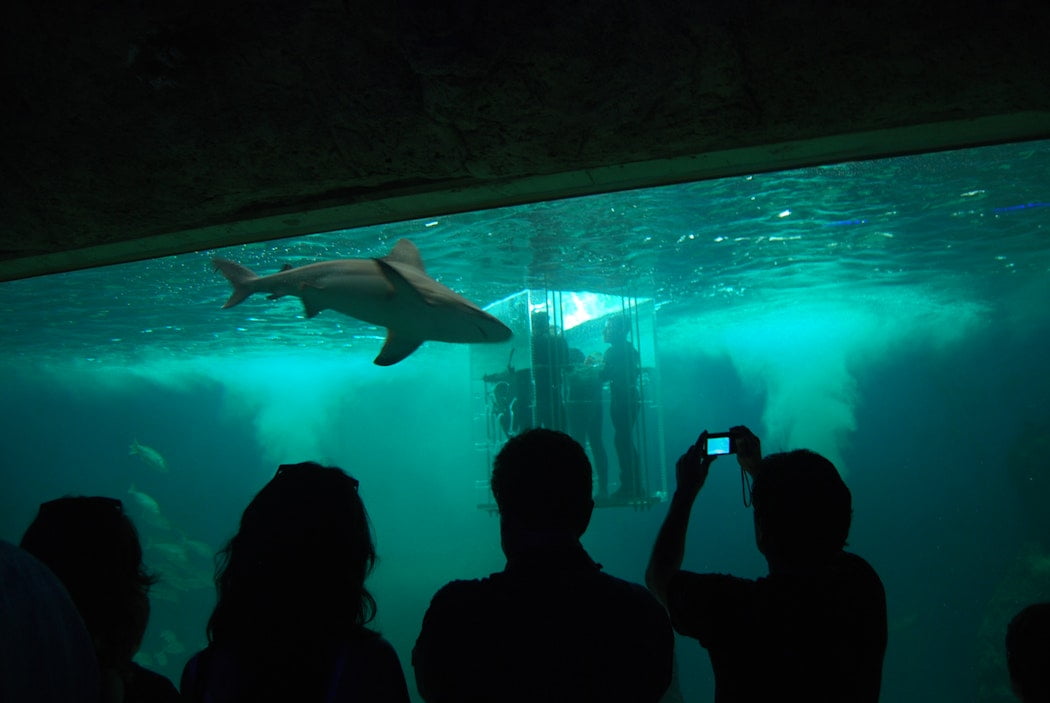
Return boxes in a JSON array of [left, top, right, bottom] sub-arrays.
[[412, 544, 674, 703]]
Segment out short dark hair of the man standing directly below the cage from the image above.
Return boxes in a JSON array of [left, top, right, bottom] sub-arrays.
[[491, 428, 593, 530]]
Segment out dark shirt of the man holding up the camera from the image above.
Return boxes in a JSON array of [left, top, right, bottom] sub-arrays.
[[668, 552, 886, 703]]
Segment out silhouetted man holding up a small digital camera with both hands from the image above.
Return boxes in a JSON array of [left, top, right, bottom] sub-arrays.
[[646, 427, 886, 703]]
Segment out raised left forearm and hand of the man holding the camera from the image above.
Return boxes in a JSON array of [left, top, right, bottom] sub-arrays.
[[646, 430, 715, 606]]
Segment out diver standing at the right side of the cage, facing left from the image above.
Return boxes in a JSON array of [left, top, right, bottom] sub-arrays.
[[602, 315, 642, 498]]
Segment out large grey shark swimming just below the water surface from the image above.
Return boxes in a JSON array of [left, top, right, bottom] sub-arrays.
[[212, 239, 511, 366]]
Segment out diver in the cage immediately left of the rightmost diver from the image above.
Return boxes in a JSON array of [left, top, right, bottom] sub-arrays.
[[565, 348, 609, 498]]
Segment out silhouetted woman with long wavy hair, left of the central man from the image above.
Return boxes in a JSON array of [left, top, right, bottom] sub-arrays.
[[181, 463, 408, 703]]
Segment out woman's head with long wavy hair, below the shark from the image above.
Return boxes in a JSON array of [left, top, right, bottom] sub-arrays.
[[208, 462, 376, 649]]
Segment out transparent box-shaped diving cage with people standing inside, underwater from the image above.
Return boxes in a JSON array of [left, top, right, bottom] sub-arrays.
[[470, 290, 668, 512]]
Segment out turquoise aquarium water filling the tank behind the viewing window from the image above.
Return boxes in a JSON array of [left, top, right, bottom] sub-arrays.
[[0, 142, 1050, 701]]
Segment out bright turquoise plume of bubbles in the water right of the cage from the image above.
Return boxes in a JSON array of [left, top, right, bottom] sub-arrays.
[[665, 291, 985, 474]]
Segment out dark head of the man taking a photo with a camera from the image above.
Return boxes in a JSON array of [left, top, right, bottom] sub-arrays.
[[751, 449, 853, 563]]
